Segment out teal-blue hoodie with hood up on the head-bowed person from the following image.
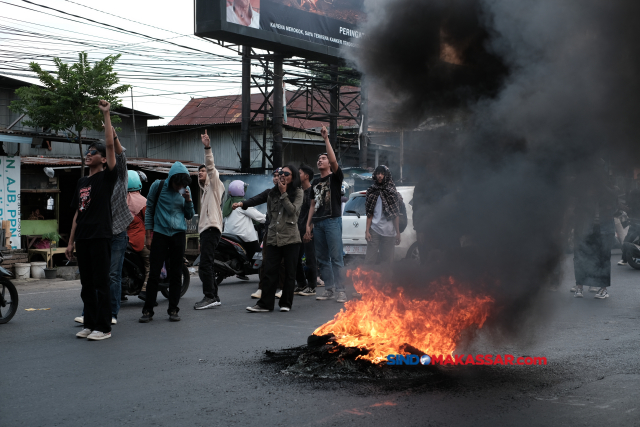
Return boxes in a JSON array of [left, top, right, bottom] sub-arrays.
[[144, 162, 195, 236]]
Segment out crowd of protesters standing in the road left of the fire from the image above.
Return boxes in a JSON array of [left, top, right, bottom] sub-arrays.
[[66, 101, 401, 340]]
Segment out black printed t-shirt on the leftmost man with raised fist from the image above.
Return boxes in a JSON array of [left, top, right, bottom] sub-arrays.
[[71, 167, 118, 240]]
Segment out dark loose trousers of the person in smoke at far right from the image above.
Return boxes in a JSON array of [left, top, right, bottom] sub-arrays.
[[573, 231, 613, 288]]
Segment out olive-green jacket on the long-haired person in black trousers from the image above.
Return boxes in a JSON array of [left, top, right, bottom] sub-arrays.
[[267, 188, 304, 246]]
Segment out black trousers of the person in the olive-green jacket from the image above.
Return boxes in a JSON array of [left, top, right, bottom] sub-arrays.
[[258, 243, 300, 310]]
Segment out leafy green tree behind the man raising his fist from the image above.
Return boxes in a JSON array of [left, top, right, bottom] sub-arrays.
[[9, 52, 131, 176]]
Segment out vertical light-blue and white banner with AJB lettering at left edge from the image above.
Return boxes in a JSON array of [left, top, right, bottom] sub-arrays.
[[0, 156, 21, 249]]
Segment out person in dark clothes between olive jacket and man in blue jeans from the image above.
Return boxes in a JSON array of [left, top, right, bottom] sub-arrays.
[[293, 164, 318, 296]]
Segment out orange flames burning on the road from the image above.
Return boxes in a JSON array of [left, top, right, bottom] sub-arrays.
[[314, 268, 494, 363]]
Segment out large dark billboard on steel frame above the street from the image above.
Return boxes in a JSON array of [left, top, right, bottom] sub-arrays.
[[195, 0, 365, 63]]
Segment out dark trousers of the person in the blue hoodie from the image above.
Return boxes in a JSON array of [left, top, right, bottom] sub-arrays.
[[142, 231, 185, 316]]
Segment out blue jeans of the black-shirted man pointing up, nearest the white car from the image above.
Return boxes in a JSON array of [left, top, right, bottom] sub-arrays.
[[313, 218, 344, 292]]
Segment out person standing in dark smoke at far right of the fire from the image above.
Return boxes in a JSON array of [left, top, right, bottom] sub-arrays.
[[572, 165, 617, 299]]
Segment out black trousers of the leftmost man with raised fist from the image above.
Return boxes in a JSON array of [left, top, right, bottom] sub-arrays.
[[76, 238, 111, 333]]
